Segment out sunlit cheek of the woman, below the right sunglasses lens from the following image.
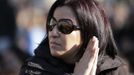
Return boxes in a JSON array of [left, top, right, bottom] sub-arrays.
[[66, 31, 81, 50]]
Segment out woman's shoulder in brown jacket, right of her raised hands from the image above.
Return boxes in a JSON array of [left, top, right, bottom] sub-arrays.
[[99, 56, 128, 75]]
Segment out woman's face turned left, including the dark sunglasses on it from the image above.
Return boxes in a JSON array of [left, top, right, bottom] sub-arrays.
[[48, 6, 81, 58]]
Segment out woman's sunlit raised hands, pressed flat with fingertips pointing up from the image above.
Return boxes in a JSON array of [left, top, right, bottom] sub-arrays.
[[73, 36, 99, 75]]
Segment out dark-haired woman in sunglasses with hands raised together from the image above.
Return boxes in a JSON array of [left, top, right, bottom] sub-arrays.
[[20, 0, 128, 75]]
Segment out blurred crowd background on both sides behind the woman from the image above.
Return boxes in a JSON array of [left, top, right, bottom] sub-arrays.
[[0, 0, 134, 75]]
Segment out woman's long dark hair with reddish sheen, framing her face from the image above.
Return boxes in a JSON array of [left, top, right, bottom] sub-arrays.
[[47, 0, 117, 58]]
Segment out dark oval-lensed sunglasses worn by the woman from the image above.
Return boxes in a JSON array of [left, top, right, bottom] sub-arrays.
[[48, 17, 80, 34]]
